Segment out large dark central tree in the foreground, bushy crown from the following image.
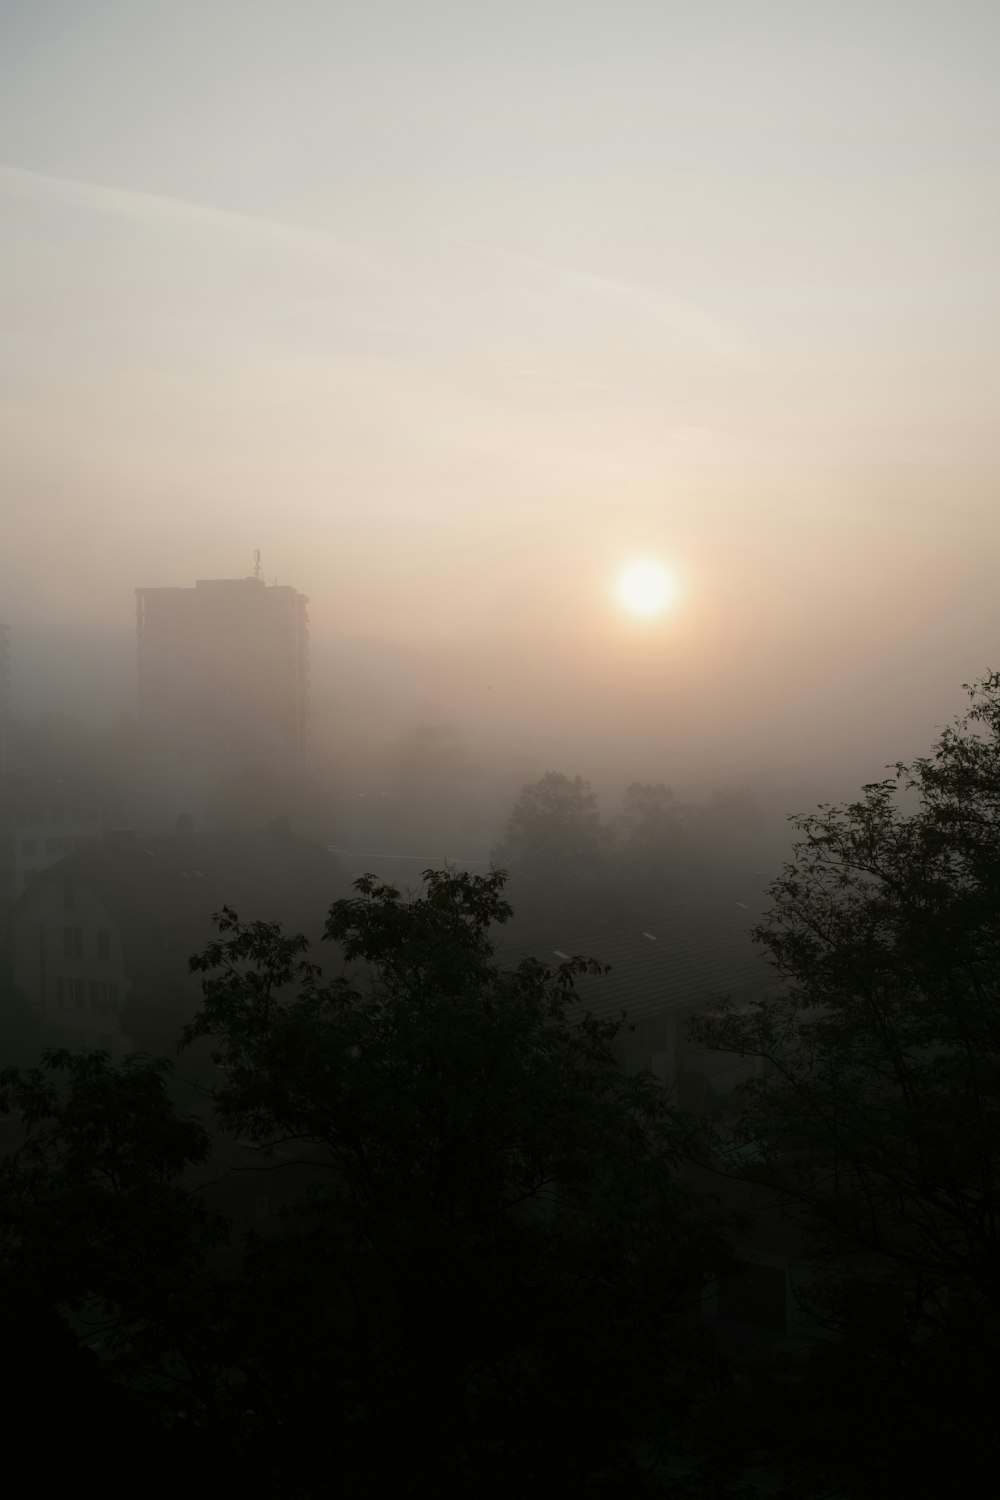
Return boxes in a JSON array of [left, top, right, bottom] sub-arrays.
[[186, 872, 740, 1496]]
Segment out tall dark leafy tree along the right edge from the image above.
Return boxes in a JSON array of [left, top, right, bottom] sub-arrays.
[[694, 674, 1000, 1496]]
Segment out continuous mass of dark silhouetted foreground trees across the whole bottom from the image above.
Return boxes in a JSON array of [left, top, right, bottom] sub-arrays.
[[0, 677, 1000, 1500]]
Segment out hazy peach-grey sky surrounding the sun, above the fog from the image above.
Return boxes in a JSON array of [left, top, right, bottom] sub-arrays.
[[0, 0, 1000, 792]]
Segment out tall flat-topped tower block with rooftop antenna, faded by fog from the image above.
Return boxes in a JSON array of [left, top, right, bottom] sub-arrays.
[[135, 569, 309, 786]]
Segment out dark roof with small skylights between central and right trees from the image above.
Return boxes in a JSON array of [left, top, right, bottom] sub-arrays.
[[496, 893, 777, 1022]]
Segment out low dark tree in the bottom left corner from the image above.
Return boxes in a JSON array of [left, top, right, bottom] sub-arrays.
[[0, 1050, 225, 1470]]
